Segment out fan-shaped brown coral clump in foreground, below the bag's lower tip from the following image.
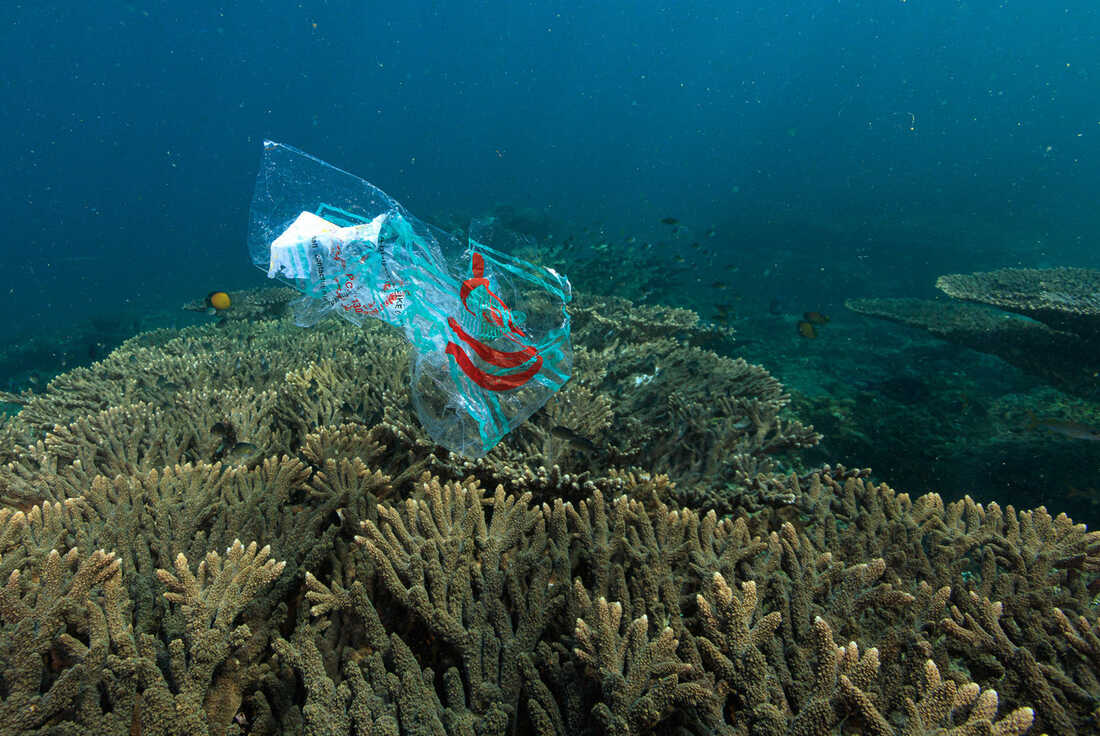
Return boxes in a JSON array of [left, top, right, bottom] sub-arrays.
[[356, 480, 565, 722]]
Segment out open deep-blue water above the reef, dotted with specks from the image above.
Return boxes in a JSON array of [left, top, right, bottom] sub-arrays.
[[0, 0, 1100, 336]]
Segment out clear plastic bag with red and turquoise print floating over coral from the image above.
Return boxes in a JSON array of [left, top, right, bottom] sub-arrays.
[[249, 141, 573, 458]]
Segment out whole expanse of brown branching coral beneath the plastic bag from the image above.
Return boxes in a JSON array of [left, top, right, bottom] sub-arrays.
[[0, 295, 1100, 736]]
